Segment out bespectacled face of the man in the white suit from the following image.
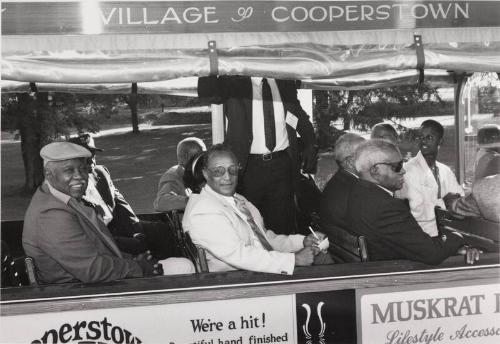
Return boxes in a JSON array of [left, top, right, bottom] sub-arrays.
[[203, 152, 240, 196]]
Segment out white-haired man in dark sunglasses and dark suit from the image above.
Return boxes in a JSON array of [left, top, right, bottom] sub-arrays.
[[347, 140, 479, 264]]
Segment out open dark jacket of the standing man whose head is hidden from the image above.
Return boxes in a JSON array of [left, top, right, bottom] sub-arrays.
[[198, 76, 315, 182]]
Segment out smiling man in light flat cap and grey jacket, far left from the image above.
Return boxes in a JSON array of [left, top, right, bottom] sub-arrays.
[[23, 142, 193, 283]]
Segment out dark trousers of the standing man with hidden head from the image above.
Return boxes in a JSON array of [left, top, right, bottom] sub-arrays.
[[238, 154, 296, 234]]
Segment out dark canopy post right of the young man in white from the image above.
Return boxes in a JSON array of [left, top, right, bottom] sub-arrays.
[[453, 73, 467, 184]]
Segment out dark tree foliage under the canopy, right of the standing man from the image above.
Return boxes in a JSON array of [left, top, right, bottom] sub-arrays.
[[313, 84, 450, 148]]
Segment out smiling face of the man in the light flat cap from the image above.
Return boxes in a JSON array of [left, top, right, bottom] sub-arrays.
[[45, 158, 89, 200]]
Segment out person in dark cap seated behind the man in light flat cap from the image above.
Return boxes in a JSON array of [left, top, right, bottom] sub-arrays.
[[68, 134, 180, 259]]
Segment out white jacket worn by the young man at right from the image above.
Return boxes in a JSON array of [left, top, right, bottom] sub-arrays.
[[395, 152, 464, 237]]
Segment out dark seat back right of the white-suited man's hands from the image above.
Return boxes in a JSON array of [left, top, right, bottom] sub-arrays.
[[314, 224, 369, 263]]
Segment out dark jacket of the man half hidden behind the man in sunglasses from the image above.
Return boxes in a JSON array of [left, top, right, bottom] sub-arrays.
[[320, 168, 358, 235]]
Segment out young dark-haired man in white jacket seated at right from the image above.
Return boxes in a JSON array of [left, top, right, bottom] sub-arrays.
[[396, 120, 464, 237]]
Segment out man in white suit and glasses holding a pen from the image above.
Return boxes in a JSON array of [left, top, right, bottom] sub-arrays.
[[182, 144, 324, 275]]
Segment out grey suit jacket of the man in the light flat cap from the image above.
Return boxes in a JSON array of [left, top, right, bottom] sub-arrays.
[[23, 184, 142, 283]]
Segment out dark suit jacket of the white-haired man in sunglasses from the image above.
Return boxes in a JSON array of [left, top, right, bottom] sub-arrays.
[[347, 180, 463, 264]]
